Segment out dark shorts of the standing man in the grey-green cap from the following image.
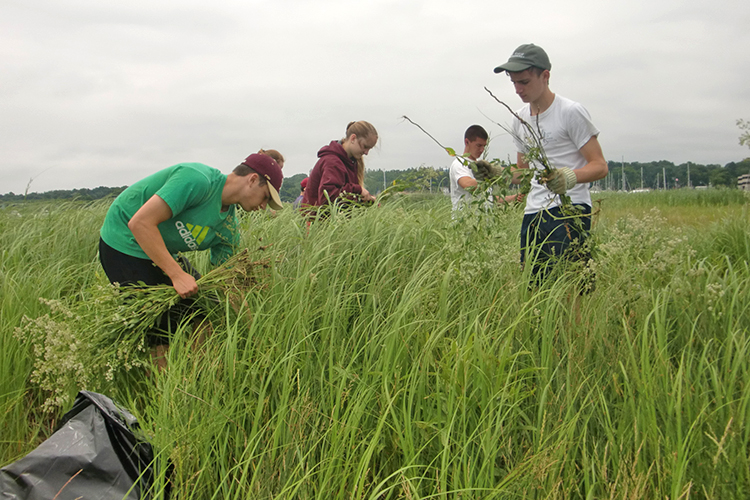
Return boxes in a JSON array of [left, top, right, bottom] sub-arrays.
[[521, 204, 591, 279]]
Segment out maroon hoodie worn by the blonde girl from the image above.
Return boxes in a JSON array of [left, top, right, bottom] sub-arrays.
[[302, 141, 362, 206]]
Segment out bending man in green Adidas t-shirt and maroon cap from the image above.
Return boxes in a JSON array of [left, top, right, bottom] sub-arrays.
[[99, 154, 283, 298]]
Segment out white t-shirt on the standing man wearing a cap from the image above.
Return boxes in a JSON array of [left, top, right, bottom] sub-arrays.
[[513, 95, 599, 214]]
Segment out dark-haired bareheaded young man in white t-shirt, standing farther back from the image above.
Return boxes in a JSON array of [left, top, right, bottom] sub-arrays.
[[449, 125, 522, 211]]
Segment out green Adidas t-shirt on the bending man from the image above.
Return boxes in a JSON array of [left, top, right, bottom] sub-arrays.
[[100, 163, 239, 265]]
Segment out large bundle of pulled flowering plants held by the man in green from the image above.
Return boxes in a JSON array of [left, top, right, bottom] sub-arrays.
[[14, 250, 269, 411]]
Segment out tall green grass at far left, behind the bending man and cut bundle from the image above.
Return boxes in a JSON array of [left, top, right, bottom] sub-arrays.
[[0, 202, 108, 463]]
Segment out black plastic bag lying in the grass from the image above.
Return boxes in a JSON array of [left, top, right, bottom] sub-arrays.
[[0, 391, 160, 500]]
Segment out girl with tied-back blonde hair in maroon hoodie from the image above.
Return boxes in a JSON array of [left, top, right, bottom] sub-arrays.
[[302, 121, 378, 206]]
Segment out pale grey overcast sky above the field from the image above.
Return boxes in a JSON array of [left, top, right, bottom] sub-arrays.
[[0, 0, 750, 193]]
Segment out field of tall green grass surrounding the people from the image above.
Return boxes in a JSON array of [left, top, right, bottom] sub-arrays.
[[0, 190, 750, 500]]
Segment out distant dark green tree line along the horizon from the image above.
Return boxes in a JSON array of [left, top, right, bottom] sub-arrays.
[[0, 158, 750, 202]]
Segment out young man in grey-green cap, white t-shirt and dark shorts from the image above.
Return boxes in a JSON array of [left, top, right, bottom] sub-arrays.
[[495, 44, 608, 282]]
